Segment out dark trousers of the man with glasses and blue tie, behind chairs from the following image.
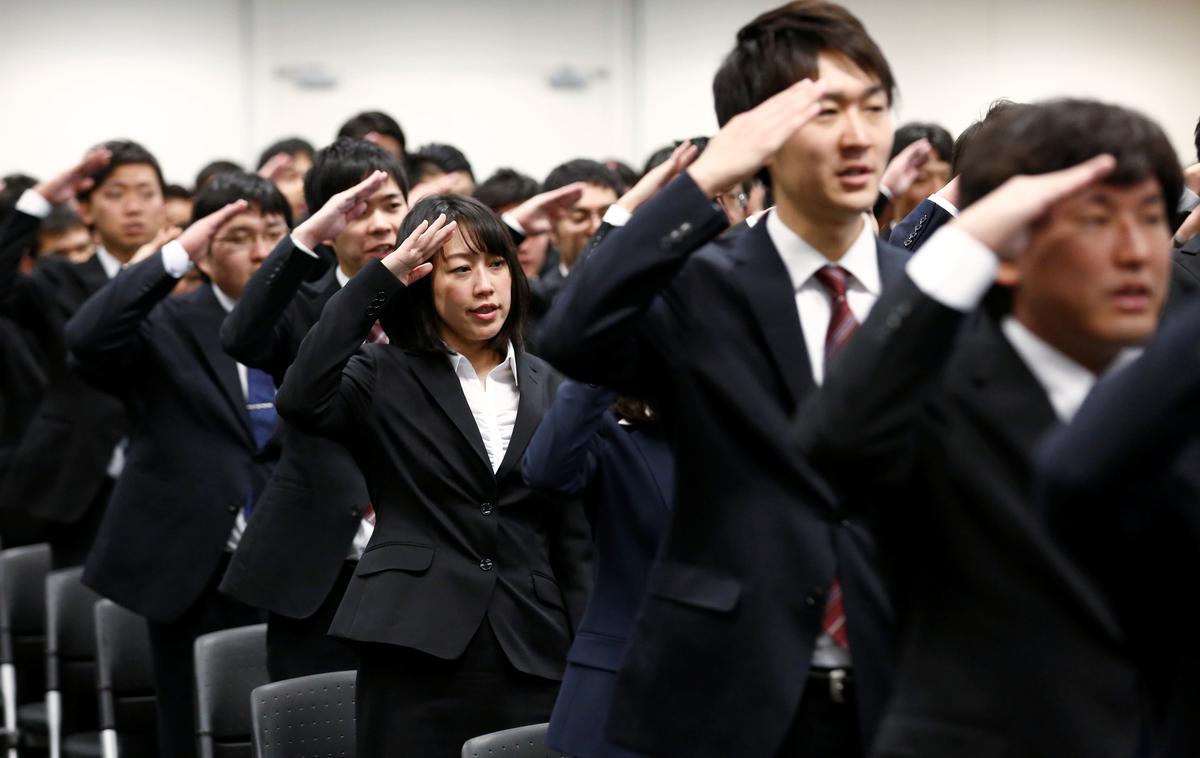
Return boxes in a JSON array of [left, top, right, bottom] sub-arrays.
[[148, 554, 262, 758]]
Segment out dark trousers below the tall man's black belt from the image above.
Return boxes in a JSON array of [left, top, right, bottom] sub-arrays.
[[779, 675, 863, 758]]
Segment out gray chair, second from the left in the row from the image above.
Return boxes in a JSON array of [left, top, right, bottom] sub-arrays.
[[46, 567, 100, 758]]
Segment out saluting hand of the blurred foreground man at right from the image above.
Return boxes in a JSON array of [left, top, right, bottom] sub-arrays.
[[949, 155, 1116, 259]]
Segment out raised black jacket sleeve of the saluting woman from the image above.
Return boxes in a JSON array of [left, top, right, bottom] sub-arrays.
[[275, 260, 403, 438]]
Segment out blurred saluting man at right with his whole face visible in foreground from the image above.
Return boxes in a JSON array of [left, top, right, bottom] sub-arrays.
[[798, 101, 1181, 758]]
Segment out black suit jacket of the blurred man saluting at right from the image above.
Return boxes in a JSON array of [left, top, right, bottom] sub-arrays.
[[798, 279, 1140, 758]]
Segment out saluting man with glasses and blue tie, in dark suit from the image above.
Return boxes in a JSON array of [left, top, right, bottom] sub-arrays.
[[67, 174, 290, 756]]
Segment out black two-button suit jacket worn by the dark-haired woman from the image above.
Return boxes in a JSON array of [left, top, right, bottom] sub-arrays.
[[277, 261, 589, 679]]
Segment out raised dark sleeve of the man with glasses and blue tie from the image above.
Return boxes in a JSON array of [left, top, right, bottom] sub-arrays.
[[66, 251, 178, 386]]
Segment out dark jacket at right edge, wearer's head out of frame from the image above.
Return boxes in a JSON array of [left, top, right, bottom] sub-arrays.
[[1038, 292, 1200, 758]]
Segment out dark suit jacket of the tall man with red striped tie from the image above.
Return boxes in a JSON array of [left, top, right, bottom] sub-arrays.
[[541, 174, 907, 758]]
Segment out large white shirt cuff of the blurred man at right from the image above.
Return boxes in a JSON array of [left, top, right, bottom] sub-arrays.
[[905, 225, 1000, 312]]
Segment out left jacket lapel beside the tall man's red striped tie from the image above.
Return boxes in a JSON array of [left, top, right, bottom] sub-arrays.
[[733, 223, 812, 402]]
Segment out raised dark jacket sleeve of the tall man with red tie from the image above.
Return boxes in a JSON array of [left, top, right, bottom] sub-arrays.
[[539, 174, 728, 397]]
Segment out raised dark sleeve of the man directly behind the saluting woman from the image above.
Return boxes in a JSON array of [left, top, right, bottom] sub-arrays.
[[221, 236, 320, 380]]
